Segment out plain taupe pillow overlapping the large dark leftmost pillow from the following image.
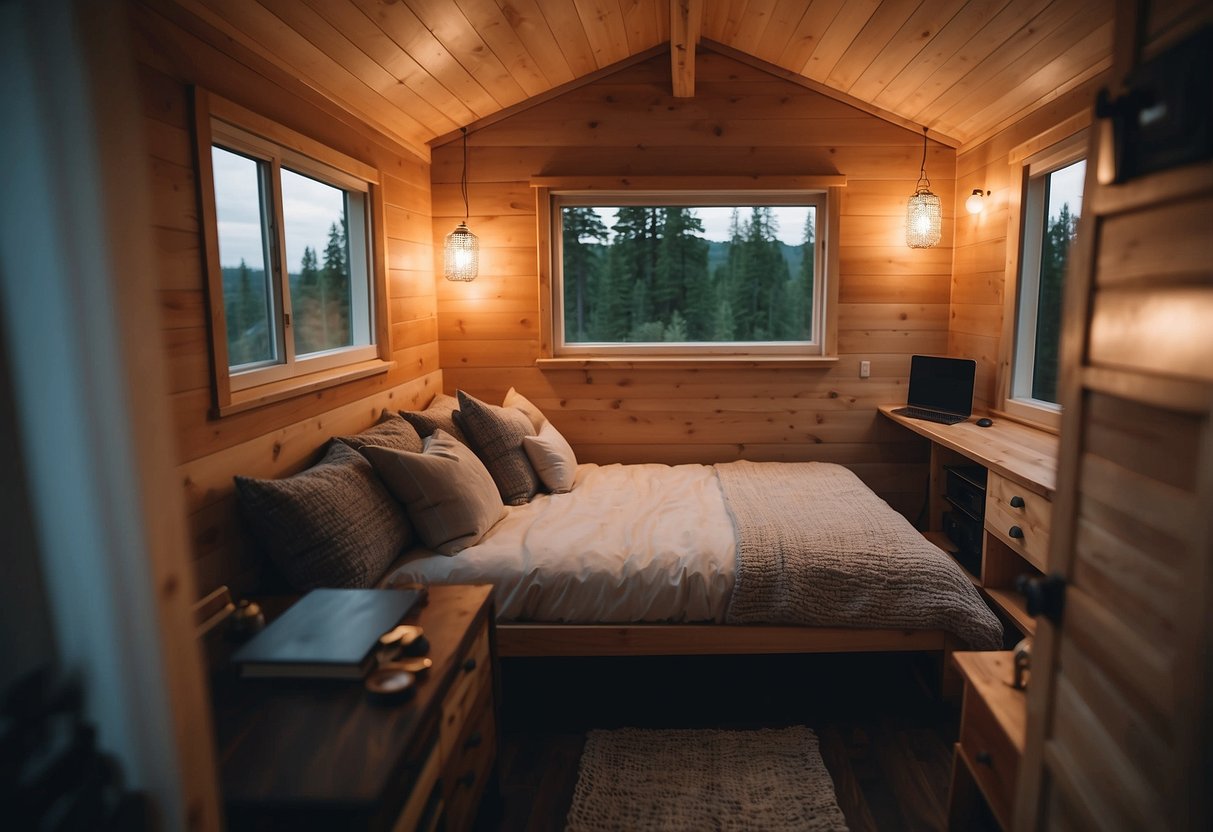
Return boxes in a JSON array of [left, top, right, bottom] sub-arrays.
[[365, 429, 506, 554]]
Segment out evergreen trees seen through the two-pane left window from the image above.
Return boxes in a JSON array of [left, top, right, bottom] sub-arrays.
[[223, 220, 353, 366]]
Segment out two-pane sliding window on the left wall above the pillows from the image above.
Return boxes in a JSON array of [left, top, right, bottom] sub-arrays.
[[199, 96, 386, 414]]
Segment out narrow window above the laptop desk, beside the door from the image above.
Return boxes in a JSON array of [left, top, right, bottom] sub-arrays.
[[1006, 136, 1087, 427]]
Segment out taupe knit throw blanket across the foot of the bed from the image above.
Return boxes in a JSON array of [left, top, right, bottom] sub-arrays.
[[716, 462, 1002, 650]]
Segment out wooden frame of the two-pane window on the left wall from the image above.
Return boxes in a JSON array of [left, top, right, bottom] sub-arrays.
[[194, 87, 392, 416]]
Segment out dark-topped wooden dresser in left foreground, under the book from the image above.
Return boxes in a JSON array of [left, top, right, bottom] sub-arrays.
[[213, 586, 499, 831]]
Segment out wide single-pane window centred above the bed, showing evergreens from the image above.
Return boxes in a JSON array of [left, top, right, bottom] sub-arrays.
[[538, 189, 828, 358]]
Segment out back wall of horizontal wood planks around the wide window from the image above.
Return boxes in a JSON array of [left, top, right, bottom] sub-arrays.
[[432, 50, 955, 517]]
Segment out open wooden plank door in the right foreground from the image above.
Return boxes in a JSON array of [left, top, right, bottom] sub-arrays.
[[1014, 2, 1213, 831]]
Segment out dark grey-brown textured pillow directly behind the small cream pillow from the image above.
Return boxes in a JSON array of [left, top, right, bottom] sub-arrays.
[[455, 391, 539, 506]]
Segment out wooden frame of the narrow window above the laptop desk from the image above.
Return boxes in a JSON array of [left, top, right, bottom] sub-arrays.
[[998, 129, 1089, 433]]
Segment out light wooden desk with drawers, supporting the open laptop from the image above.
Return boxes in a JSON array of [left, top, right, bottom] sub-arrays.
[[879, 404, 1059, 636]]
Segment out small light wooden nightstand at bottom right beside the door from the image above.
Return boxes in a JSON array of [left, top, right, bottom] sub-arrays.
[[947, 650, 1027, 830]]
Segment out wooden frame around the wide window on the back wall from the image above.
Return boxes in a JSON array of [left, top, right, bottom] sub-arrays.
[[531, 176, 845, 366]]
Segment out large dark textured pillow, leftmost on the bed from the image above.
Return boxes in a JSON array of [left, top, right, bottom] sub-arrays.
[[235, 443, 412, 592]]
